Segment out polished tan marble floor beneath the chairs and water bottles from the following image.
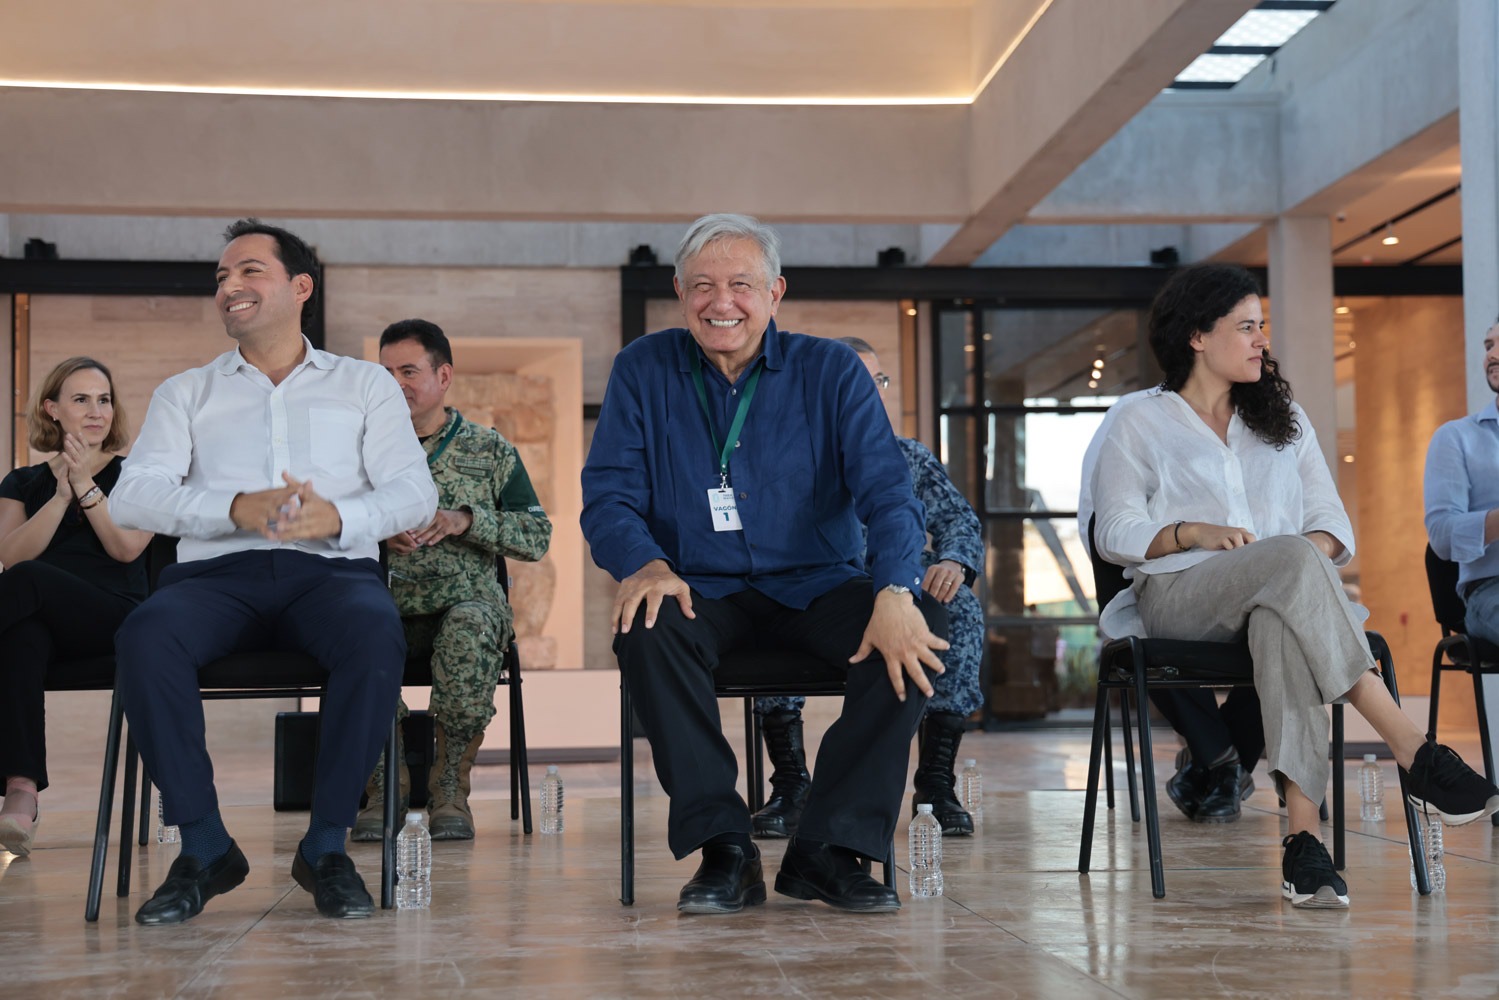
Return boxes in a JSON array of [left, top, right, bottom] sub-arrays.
[[0, 707, 1499, 999]]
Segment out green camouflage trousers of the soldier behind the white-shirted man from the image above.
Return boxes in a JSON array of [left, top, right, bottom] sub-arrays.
[[399, 601, 514, 747]]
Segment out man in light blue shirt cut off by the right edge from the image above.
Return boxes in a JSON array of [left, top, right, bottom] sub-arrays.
[[1426, 322, 1499, 643]]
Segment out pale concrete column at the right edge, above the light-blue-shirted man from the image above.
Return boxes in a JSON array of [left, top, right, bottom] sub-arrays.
[[1457, 0, 1499, 412]]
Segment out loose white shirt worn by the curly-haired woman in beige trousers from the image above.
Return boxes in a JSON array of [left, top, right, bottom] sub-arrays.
[[1093, 393, 1354, 637]]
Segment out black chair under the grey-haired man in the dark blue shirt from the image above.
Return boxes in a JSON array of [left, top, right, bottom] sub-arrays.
[[619, 649, 895, 906]]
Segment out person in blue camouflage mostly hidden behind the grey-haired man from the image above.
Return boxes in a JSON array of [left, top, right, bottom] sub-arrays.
[[751, 337, 983, 837]]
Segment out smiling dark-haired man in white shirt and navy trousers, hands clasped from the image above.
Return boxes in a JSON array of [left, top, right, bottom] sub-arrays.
[[111, 219, 438, 925]]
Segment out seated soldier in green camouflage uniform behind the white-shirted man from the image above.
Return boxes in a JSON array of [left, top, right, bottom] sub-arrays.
[[354, 319, 552, 840]]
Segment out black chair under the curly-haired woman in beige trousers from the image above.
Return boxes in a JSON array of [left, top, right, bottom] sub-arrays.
[[1078, 522, 1432, 900]]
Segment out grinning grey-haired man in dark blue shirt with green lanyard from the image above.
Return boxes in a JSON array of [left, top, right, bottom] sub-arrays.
[[582, 214, 947, 913]]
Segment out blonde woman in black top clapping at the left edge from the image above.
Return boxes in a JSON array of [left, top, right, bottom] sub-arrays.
[[0, 357, 151, 855]]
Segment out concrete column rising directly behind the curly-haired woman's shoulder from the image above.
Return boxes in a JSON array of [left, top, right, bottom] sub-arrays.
[[1268, 216, 1339, 478]]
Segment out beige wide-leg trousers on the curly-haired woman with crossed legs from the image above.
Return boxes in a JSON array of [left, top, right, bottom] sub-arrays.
[[1135, 535, 1375, 802]]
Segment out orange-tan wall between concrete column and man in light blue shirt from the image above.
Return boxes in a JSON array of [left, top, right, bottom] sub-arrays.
[[1354, 298, 1477, 729]]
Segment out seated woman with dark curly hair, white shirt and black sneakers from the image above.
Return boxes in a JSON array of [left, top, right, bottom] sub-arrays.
[[1094, 264, 1499, 909]]
